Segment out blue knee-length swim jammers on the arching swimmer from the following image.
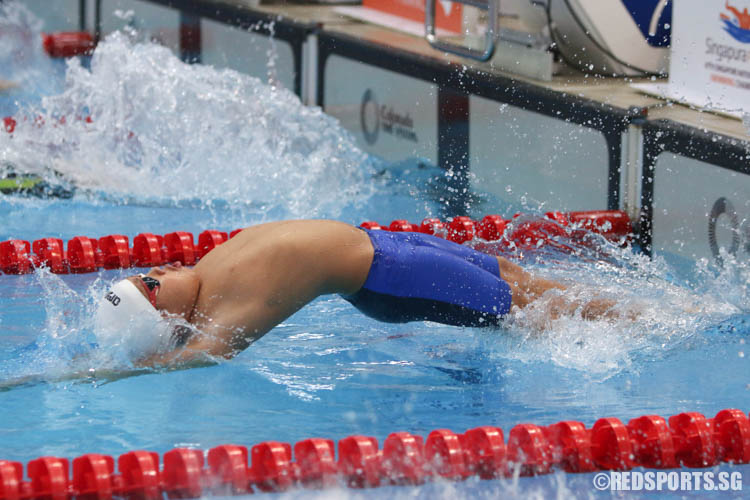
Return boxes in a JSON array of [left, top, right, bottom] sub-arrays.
[[344, 229, 511, 326]]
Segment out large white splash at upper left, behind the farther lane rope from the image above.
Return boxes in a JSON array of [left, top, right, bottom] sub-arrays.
[[0, 33, 371, 217]]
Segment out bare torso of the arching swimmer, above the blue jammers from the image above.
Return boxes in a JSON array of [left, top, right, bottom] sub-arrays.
[[195, 220, 373, 340]]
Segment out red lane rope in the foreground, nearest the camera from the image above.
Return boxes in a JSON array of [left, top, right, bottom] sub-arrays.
[[0, 409, 750, 500]]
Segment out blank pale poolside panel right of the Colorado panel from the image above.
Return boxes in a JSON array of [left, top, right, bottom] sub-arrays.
[[469, 96, 609, 211]]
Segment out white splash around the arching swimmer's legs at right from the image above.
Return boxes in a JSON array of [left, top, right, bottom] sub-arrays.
[[488, 235, 750, 378]]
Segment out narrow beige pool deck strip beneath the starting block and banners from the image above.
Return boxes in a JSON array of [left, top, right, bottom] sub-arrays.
[[254, 0, 750, 141]]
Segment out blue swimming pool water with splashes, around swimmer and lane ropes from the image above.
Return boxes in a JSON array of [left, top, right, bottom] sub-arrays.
[[0, 4, 750, 498]]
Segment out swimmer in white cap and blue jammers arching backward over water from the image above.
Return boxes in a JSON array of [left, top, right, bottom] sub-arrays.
[[95, 220, 614, 366]]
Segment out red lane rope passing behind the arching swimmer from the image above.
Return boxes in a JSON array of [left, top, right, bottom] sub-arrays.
[[0, 210, 632, 274]]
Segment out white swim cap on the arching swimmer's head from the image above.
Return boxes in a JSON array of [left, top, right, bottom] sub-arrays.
[[94, 280, 171, 360]]
